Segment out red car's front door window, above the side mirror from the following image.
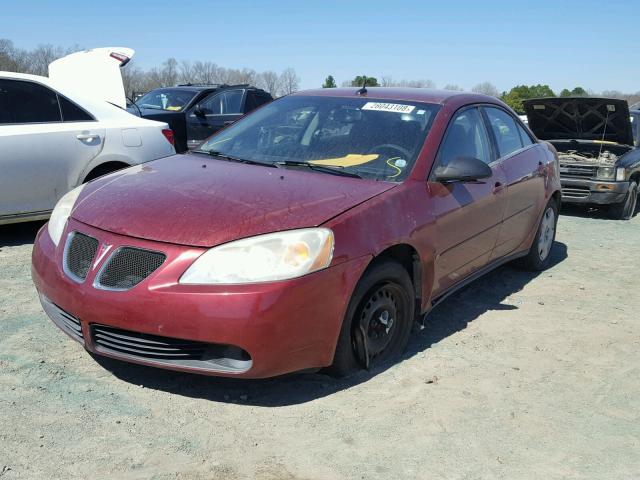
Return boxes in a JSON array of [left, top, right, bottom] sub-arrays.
[[438, 108, 494, 165]]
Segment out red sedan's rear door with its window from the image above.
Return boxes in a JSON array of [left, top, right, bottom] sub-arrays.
[[482, 106, 546, 259]]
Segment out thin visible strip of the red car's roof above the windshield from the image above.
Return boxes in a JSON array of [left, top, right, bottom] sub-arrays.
[[293, 87, 502, 105]]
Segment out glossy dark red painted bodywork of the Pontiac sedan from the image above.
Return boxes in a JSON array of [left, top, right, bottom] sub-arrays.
[[33, 89, 560, 377]]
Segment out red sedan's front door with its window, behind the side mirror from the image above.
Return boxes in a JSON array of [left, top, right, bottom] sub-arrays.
[[429, 106, 506, 296]]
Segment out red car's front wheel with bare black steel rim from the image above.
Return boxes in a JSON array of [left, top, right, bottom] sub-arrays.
[[326, 260, 415, 377]]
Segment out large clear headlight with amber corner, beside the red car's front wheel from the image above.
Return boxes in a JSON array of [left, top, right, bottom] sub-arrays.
[[180, 228, 333, 284]]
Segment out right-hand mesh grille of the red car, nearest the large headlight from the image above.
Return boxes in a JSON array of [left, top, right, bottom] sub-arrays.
[[97, 247, 167, 290]]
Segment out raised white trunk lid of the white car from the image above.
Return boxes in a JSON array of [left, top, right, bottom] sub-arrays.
[[49, 47, 135, 108]]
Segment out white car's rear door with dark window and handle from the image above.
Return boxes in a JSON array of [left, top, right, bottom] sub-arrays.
[[0, 79, 104, 216]]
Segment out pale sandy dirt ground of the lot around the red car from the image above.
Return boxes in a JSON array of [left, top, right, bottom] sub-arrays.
[[0, 210, 640, 480]]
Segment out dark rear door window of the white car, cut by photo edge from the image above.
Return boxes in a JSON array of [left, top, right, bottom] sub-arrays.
[[0, 80, 62, 123]]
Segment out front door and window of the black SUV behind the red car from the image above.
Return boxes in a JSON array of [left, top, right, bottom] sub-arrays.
[[187, 89, 245, 149]]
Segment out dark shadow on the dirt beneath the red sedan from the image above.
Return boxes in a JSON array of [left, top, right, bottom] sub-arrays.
[[94, 242, 567, 407]]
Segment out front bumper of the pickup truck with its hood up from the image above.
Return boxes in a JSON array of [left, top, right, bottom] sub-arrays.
[[560, 176, 629, 205]]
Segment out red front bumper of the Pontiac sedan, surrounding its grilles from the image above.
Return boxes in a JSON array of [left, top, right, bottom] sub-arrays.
[[32, 219, 369, 378]]
